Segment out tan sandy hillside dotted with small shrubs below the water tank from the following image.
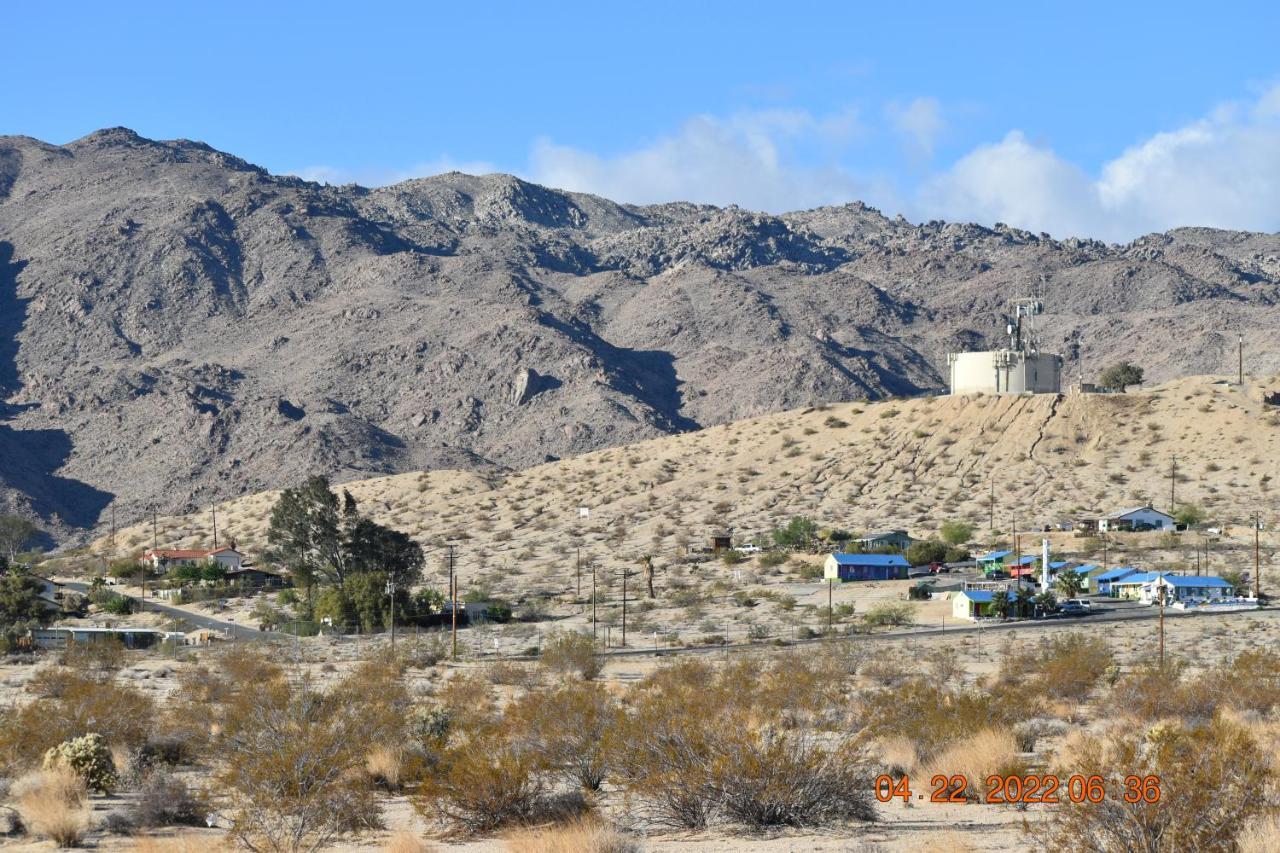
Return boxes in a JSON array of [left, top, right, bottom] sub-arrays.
[[92, 377, 1280, 580]]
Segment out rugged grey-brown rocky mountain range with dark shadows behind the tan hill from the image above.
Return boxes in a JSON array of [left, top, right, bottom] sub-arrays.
[[0, 128, 1280, 535]]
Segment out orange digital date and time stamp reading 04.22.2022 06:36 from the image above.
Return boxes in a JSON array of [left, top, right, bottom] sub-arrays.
[[876, 774, 1160, 806]]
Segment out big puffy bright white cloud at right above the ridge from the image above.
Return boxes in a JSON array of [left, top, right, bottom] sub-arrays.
[[915, 86, 1280, 241]]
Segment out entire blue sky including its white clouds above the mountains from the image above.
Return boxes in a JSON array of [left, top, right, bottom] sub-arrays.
[[0, 0, 1280, 240]]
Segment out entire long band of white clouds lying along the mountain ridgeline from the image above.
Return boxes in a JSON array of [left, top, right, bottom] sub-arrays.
[[285, 85, 1280, 241]]
